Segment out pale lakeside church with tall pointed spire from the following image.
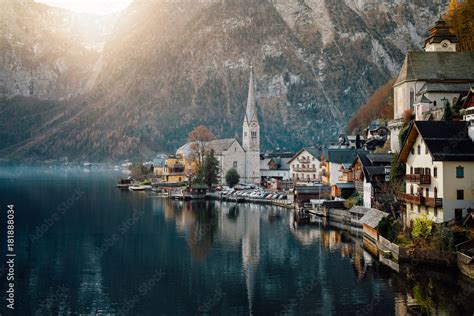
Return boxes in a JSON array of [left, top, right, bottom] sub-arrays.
[[176, 68, 261, 184]]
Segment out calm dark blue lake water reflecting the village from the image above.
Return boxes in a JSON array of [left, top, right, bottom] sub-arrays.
[[0, 167, 474, 315]]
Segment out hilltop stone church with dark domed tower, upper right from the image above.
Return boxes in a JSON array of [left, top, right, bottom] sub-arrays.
[[388, 19, 474, 152]]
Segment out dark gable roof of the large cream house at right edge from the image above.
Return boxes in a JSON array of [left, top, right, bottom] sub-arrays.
[[398, 121, 474, 162]]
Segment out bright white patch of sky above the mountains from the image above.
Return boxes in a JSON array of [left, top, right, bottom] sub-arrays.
[[36, 0, 132, 14]]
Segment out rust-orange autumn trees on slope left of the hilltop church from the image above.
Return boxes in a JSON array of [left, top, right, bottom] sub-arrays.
[[347, 79, 395, 133]]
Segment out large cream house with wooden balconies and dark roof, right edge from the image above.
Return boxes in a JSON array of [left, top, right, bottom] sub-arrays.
[[398, 121, 474, 226]]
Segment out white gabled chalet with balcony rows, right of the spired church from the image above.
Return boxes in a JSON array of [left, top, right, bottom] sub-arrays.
[[288, 147, 321, 185]]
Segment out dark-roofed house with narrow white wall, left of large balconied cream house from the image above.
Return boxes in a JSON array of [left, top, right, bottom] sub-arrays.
[[351, 152, 393, 208]]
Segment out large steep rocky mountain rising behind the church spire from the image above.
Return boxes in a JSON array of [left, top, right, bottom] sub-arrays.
[[0, 0, 447, 160]]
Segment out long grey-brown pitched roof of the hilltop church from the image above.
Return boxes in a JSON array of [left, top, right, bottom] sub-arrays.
[[395, 51, 474, 86]]
